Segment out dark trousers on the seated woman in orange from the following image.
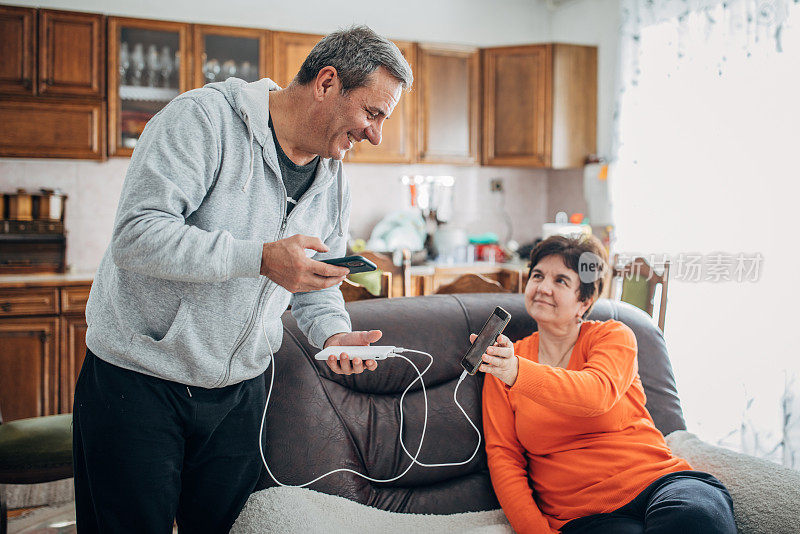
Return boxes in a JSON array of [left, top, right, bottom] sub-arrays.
[[561, 471, 736, 534]]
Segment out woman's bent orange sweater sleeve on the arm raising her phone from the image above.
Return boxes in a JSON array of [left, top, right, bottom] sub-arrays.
[[510, 321, 639, 417]]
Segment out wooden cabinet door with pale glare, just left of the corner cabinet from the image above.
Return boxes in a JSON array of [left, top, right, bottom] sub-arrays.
[[414, 44, 480, 164]]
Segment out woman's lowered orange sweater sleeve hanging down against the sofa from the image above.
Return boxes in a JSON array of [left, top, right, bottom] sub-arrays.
[[482, 375, 555, 534]]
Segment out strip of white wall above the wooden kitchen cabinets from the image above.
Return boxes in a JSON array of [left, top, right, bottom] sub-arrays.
[[7, 0, 549, 46]]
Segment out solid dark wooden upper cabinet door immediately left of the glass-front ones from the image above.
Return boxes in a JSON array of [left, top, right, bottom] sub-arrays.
[[38, 9, 106, 98]]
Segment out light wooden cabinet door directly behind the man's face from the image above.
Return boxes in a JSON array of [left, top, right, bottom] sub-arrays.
[[347, 41, 417, 163]]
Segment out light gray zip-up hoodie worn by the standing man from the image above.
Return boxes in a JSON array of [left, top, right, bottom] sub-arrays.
[[86, 78, 351, 388]]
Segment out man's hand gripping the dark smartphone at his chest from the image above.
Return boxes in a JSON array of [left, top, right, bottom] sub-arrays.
[[261, 234, 350, 293]]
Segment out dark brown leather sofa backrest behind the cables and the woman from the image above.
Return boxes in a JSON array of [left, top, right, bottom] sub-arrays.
[[258, 294, 685, 514]]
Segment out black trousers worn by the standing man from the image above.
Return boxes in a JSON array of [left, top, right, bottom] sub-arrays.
[[73, 351, 266, 533]]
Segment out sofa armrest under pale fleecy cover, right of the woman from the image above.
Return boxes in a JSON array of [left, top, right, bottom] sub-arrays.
[[666, 430, 800, 534]]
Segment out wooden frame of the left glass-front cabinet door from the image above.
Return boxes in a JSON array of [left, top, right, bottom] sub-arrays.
[[106, 17, 192, 157]]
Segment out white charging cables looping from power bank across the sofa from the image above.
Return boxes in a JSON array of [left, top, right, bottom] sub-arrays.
[[258, 298, 481, 488]]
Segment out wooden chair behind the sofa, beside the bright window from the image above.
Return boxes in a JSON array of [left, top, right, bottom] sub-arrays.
[[609, 254, 669, 332]]
